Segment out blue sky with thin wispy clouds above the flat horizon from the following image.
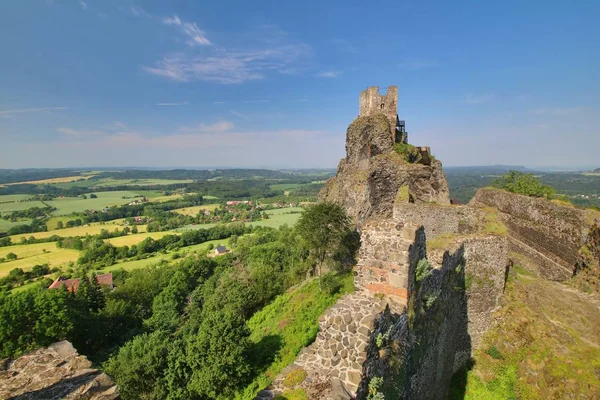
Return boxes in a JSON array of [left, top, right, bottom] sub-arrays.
[[0, 0, 600, 168]]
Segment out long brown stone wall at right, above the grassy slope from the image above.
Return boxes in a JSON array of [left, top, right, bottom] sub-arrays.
[[469, 189, 589, 280]]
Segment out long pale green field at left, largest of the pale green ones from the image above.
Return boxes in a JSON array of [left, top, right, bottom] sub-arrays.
[[46, 191, 143, 216]]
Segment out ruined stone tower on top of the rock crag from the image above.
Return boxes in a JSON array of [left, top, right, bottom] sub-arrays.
[[358, 86, 408, 143]]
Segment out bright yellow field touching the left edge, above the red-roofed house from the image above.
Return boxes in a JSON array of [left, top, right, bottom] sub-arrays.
[[0, 243, 79, 277]]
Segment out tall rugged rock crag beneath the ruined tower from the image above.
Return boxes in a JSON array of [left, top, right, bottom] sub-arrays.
[[320, 114, 450, 223]]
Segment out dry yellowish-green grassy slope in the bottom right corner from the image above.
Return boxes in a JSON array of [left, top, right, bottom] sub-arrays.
[[450, 267, 600, 399]]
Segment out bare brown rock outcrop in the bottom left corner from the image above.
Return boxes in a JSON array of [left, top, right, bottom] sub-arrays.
[[0, 341, 120, 400]]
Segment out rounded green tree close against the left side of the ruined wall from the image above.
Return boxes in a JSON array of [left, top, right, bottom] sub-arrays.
[[296, 202, 352, 284]]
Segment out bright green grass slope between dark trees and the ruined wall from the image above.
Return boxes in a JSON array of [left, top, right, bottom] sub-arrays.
[[236, 273, 354, 400]]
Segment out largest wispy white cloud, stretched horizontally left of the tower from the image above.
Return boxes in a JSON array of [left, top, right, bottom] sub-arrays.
[[142, 44, 310, 84]]
